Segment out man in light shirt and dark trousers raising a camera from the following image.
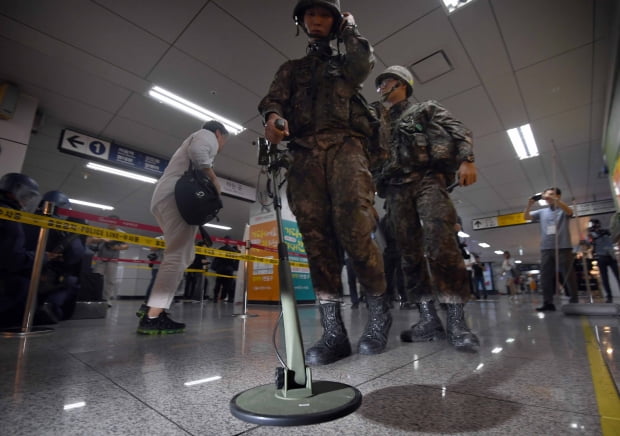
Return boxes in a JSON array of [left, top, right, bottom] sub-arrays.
[[523, 187, 579, 312]]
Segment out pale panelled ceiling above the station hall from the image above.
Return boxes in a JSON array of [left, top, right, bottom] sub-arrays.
[[0, 0, 615, 262]]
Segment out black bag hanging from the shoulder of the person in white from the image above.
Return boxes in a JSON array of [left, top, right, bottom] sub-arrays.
[[174, 162, 223, 226]]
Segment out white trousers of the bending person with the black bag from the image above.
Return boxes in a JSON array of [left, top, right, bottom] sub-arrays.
[[147, 195, 198, 309]]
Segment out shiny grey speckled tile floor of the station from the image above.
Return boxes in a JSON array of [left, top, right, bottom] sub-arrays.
[[0, 295, 620, 436]]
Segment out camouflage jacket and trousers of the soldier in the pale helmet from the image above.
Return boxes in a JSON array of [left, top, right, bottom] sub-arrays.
[[378, 100, 473, 304]]
